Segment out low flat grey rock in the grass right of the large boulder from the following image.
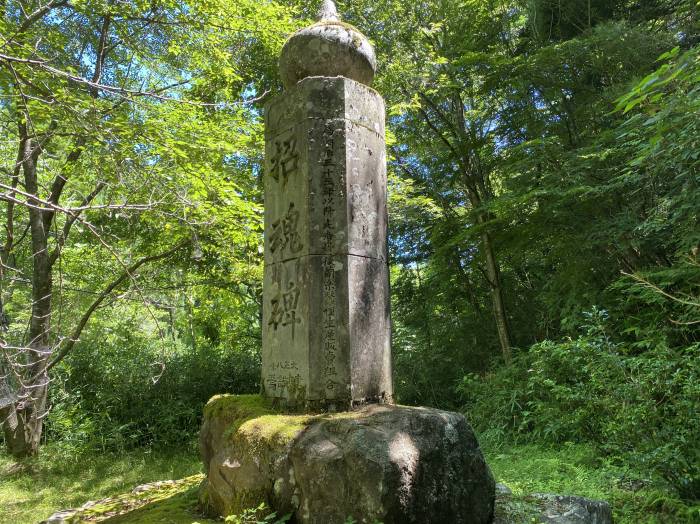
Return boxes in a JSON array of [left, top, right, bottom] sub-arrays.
[[493, 484, 612, 524]]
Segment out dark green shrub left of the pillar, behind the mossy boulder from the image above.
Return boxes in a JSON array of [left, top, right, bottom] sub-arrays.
[[46, 333, 260, 450]]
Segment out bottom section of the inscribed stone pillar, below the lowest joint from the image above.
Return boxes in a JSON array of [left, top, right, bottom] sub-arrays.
[[263, 256, 392, 410]]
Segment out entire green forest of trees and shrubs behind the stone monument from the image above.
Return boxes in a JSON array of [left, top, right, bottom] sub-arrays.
[[0, 0, 700, 521]]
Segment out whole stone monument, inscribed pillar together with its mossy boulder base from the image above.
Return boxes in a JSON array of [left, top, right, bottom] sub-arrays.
[[199, 0, 495, 524]]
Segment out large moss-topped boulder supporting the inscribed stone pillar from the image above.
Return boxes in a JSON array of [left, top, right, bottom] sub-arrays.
[[200, 396, 495, 524]]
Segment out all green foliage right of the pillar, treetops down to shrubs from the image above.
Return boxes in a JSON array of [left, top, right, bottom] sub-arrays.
[[378, 13, 700, 504]]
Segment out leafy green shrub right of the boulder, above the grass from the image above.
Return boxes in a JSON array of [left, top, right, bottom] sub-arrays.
[[458, 311, 700, 499]]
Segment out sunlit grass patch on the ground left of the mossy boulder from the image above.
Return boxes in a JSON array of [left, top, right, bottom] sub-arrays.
[[0, 445, 205, 524]]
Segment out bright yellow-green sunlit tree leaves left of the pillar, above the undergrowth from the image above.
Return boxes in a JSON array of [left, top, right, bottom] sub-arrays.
[[0, 0, 299, 372]]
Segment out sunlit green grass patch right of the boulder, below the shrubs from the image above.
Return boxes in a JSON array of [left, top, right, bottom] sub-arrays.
[[485, 445, 700, 524]]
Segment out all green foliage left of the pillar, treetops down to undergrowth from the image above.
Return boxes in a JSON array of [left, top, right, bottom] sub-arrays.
[[0, 0, 294, 454]]
